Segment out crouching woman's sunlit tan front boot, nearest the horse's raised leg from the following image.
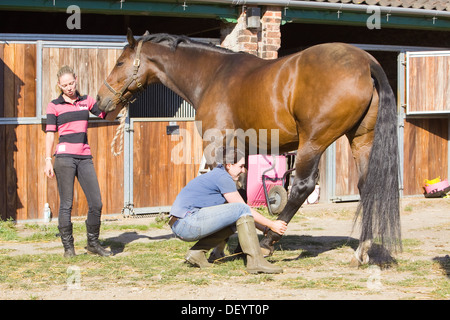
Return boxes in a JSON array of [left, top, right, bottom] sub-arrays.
[[236, 216, 283, 273]]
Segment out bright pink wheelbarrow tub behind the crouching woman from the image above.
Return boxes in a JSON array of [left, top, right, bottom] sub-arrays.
[[247, 154, 286, 207]]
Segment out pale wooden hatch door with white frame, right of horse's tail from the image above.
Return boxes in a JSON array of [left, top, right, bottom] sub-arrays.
[[407, 54, 450, 113]]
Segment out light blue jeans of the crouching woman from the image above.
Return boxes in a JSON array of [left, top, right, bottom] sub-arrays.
[[172, 203, 251, 241]]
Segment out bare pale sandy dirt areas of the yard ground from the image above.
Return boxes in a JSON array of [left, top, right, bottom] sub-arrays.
[[0, 198, 450, 300]]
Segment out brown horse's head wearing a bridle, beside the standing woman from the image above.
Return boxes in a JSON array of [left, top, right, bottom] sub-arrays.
[[97, 29, 148, 120]]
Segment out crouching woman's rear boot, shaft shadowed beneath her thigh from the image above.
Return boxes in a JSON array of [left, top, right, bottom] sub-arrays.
[[185, 227, 234, 268]]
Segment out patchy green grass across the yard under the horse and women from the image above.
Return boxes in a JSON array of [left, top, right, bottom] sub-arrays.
[[0, 221, 450, 299]]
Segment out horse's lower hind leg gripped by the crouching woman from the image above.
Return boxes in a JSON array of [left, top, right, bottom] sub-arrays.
[[260, 146, 322, 255]]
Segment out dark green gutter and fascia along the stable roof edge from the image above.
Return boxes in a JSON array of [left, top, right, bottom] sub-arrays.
[[0, 0, 450, 31]]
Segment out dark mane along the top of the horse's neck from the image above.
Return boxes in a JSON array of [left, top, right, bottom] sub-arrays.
[[139, 33, 236, 54]]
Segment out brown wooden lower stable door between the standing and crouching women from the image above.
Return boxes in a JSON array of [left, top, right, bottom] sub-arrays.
[[133, 121, 203, 208]]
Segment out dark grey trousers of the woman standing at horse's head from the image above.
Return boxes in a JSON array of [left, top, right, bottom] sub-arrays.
[[53, 157, 102, 228]]
